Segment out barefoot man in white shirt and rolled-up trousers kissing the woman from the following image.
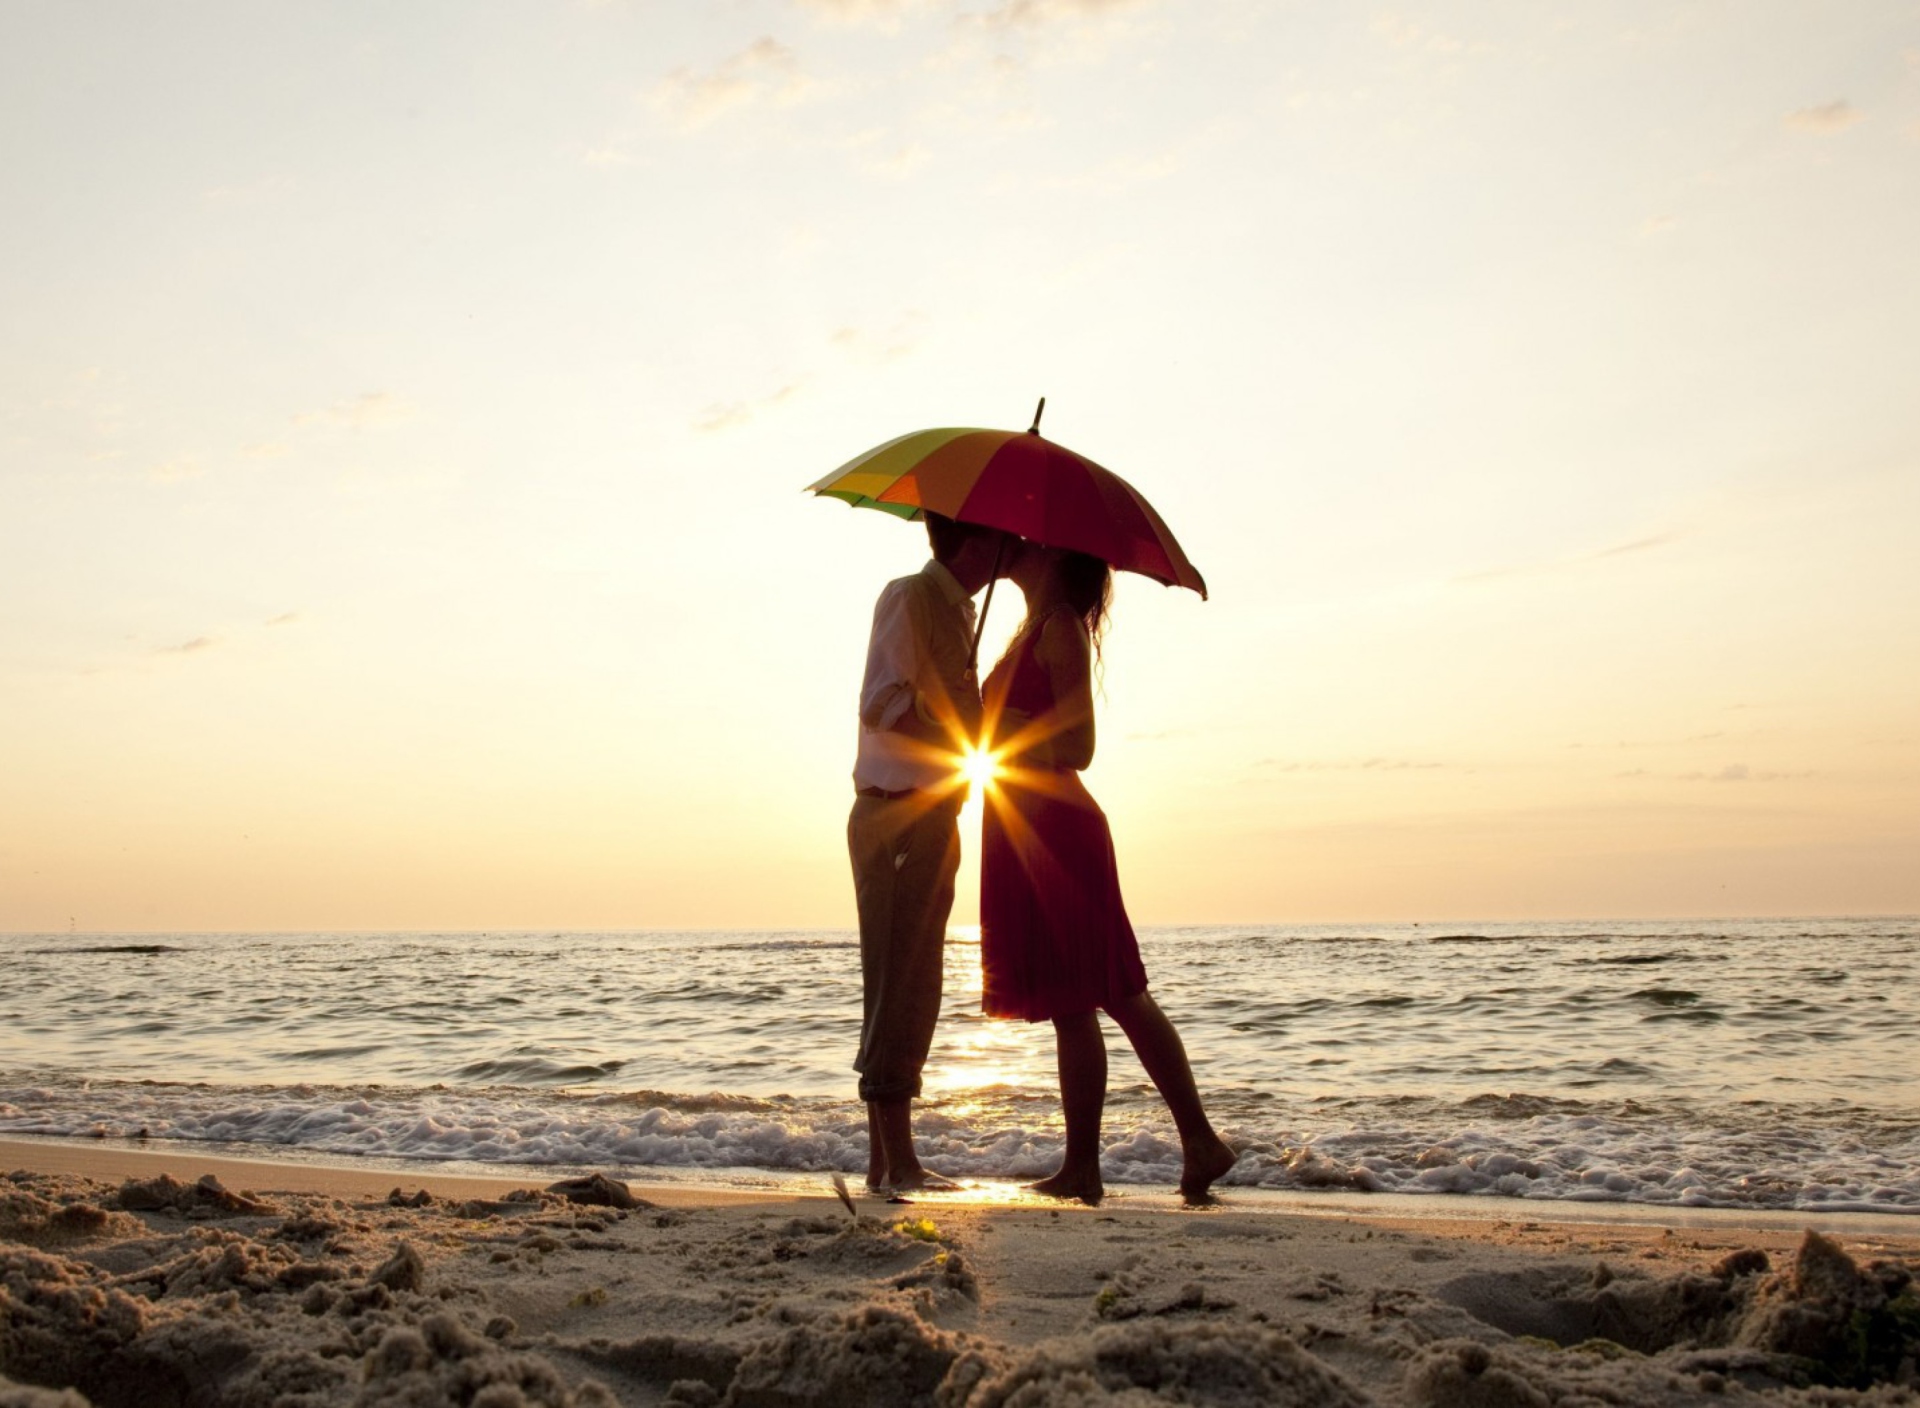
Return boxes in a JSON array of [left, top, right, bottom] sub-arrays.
[[847, 513, 1004, 1191]]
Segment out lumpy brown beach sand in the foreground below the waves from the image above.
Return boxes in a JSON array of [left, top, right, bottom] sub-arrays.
[[0, 1141, 1920, 1408]]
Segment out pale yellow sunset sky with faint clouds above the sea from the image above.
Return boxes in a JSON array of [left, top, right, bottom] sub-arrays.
[[0, 0, 1920, 932]]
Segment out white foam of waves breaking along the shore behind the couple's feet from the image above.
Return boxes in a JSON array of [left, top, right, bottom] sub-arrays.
[[0, 1076, 1920, 1214]]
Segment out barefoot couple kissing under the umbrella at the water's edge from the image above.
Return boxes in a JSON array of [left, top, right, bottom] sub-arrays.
[[847, 513, 1235, 1204]]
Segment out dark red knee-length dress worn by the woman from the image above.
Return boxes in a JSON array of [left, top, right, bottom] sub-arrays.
[[979, 630, 1146, 1022]]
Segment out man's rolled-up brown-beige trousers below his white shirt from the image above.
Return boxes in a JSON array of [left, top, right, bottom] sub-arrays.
[[847, 793, 964, 1101]]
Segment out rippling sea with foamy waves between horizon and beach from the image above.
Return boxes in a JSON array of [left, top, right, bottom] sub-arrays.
[[0, 918, 1920, 1214]]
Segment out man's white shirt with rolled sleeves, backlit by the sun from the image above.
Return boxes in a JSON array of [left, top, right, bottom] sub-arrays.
[[852, 561, 979, 791]]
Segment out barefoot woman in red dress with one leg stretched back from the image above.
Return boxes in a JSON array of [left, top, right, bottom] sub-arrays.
[[979, 542, 1235, 1202]]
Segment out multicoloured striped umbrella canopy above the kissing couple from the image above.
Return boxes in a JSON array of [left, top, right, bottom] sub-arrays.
[[808, 411, 1206, 597]]
